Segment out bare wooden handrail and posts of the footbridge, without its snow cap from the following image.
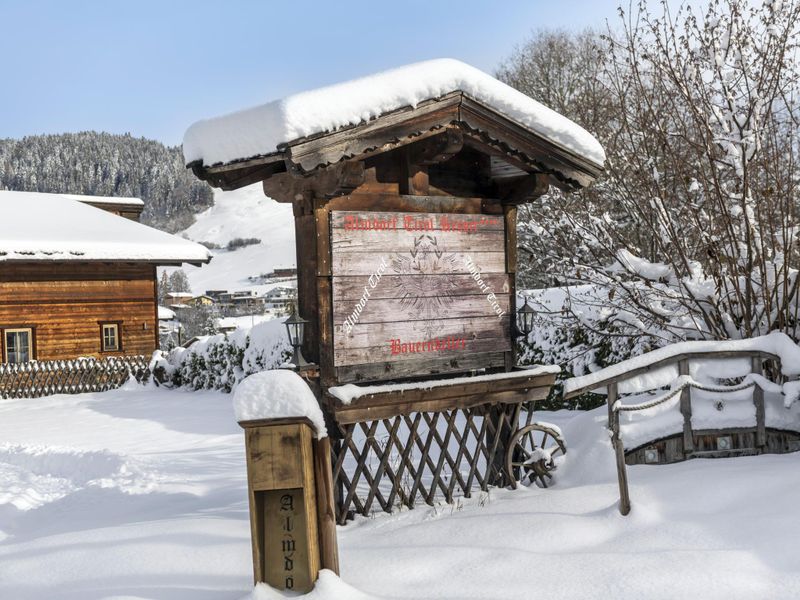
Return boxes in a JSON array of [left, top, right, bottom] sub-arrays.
[[564, 350, 780, 515]]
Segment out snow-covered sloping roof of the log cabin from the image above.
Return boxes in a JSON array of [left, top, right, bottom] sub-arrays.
[[0, 191, 211, 264]]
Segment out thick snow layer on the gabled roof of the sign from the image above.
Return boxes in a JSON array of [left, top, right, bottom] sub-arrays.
[[183, 59, 605, 168]]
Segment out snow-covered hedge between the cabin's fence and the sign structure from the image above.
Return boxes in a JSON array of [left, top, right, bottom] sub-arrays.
[[153, 319, 292, 392]]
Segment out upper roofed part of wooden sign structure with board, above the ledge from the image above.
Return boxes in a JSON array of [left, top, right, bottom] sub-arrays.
[[190, 92, 602, 392]]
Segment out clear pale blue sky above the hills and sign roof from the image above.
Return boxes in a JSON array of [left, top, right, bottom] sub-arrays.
[[0, 0, 632, 144]]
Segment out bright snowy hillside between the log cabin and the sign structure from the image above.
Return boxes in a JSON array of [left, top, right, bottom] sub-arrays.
[[166, 184, 296, 294]]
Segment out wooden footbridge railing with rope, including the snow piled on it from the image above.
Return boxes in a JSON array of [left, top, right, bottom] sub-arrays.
[[564, 332, 800, 515]]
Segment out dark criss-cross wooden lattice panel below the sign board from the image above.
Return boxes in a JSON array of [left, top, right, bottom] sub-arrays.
[[332, 404, 533, 524]]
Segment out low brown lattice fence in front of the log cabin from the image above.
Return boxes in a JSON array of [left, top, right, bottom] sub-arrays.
[[0, 356, 149, 398]]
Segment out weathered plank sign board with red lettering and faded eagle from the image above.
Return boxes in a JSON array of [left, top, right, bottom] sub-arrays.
[[331, 211, 511, 381]]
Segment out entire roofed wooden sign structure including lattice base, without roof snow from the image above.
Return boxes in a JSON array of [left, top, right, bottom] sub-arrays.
[[189, 91, 602, 544]]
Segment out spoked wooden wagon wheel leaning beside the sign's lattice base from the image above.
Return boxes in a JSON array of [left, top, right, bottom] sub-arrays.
[[506, 423, 567, 488]]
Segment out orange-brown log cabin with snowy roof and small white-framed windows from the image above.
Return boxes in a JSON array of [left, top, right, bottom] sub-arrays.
[[0, 191, 210, 363]]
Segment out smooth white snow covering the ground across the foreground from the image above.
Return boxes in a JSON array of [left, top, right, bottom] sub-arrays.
[[0, 386, 800, 600]]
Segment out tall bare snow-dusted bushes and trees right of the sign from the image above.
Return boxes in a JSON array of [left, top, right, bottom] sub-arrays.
[[505, 0, 800, 352]]
